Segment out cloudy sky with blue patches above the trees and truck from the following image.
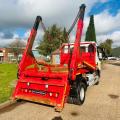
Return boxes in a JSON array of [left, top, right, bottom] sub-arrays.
[[0, 0, 120, 47]]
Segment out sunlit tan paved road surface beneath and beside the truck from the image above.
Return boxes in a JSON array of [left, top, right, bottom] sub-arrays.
[[0, 64, 120, 120]]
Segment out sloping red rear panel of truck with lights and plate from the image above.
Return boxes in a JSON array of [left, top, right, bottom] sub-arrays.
[[13, 76, 70, 109]]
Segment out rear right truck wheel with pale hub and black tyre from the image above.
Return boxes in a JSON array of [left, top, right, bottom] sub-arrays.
[[77, 82, 86, 105]]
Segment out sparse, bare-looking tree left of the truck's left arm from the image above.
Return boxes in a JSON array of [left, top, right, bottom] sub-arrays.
[[9, 39, 25, 63]]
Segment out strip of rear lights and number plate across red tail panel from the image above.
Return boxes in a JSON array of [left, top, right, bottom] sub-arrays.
[[21, 88, 59, 98]]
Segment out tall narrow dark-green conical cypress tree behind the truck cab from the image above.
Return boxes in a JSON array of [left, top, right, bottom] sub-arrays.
[[85, 15, 96, 42]]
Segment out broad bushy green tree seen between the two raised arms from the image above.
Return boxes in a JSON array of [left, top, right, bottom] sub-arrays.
[[37, 24, 67, 56]]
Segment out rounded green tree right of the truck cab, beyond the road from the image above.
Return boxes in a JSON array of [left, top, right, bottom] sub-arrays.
[[100, 39, 113, 56]]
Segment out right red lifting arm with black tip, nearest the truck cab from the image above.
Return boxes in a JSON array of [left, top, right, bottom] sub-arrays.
[[69, 4, 85, 80]]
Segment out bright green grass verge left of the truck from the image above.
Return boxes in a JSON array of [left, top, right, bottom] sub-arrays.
[[0, 63, 17, 103]]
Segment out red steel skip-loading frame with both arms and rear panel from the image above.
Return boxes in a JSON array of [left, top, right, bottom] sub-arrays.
[[13, 5, 95, 110]]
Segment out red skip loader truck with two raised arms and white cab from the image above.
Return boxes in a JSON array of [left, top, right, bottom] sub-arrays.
[[12, 4, 100, 111]]
